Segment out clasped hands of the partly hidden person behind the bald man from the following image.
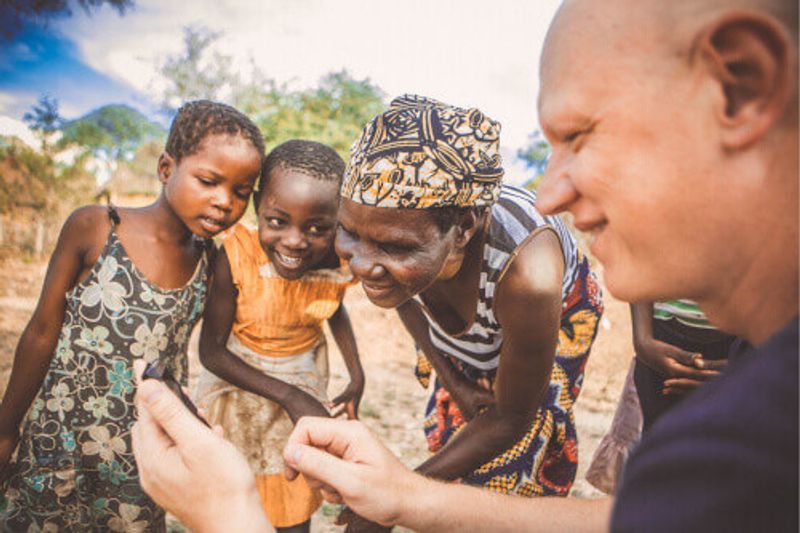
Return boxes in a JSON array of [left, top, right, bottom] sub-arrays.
[[636, 339, 727, 394]]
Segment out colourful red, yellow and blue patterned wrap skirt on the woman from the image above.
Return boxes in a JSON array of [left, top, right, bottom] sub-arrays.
[[416, 259, 603, 497]]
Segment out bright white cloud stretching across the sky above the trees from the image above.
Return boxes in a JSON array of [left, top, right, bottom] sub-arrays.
[[60, 0, 559, 154]]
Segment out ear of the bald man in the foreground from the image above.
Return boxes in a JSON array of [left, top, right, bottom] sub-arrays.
[[698, 12, 796, 150]]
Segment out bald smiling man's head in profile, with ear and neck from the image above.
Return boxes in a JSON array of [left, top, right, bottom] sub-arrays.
[[538, 0, 798, 338]]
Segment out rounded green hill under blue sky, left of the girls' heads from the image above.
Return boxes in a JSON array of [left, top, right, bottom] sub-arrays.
[[62, 104, 167, 156]]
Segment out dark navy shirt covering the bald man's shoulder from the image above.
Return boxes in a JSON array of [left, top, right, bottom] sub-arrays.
[[613, 319, 798, 531]]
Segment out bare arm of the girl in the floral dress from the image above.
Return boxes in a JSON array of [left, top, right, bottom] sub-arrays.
[[0, 207, 107, 470]]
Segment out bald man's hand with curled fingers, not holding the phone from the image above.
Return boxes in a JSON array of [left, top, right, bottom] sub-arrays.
[[283, 417, 424, 526]]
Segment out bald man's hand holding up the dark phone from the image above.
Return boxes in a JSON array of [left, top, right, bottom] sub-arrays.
[[132, 361, 272, 532]]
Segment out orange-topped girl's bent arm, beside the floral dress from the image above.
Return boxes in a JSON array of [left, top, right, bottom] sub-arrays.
[[200, 248, 330, 422]]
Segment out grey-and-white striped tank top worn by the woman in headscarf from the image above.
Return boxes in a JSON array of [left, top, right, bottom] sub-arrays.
[[422, 185, 579, 370]]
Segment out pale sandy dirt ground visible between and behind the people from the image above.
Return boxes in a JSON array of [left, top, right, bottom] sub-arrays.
[[0, 257, 633, 532]]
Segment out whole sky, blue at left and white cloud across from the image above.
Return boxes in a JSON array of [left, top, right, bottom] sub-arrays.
[[0, 0, 559, 174]]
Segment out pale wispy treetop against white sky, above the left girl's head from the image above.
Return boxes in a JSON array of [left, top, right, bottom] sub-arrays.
[[159, 26, 237, 115]]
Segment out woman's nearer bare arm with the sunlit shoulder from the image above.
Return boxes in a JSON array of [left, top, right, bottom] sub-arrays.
[[417, 231, 564, 479]]
